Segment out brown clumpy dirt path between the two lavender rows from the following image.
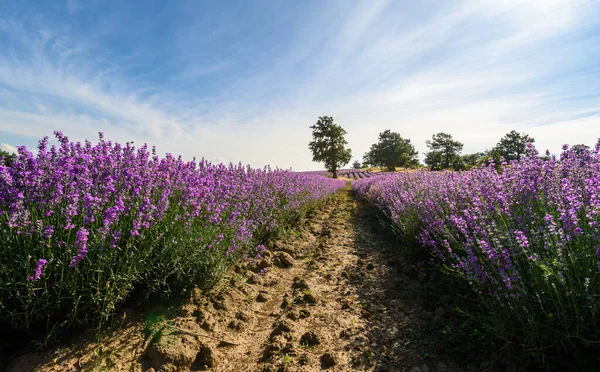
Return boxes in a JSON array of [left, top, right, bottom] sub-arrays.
[[8, 190, 468, 372]]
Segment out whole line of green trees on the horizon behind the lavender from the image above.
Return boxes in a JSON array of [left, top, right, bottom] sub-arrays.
[[309, 116, 544, 178]]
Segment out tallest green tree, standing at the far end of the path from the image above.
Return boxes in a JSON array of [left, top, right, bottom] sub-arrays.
[[308, 116, 352, 178]]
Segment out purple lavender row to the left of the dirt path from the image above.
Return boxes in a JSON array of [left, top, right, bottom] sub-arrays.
[[0, 132, 344, 327]]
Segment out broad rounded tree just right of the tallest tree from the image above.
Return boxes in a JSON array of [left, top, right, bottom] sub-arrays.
[[363, 129, 419, 171]]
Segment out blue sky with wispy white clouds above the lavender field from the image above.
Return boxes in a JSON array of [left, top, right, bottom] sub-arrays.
[[0, 0, 600, 170]]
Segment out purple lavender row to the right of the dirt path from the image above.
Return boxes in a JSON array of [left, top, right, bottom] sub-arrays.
[[353, 142, 600, 350]]
